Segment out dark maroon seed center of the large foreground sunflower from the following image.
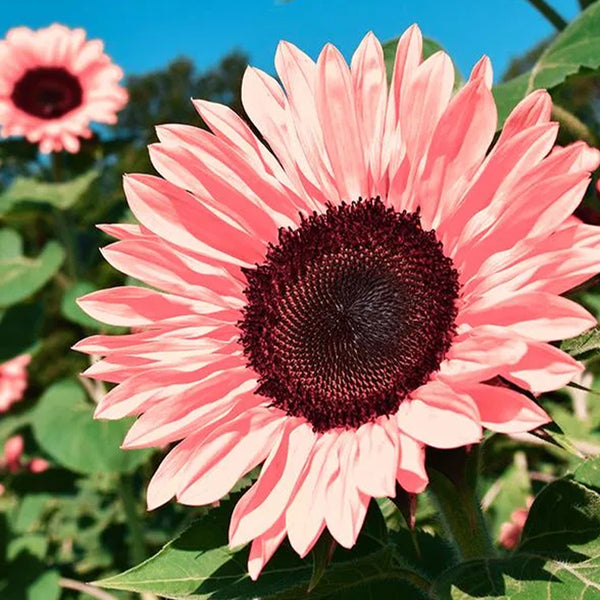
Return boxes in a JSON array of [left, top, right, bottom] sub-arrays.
[[239, 198, 458, 431]]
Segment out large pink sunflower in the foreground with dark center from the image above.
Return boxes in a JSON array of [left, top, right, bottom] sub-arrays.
[[76, 26, 600, 578]]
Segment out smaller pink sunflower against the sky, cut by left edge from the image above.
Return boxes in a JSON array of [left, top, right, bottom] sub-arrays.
[[0, 24, 127, 153]]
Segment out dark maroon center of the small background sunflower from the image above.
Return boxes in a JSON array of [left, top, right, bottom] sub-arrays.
[[11, 67, 83, 119]]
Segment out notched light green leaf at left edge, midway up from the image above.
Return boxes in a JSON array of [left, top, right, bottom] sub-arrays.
[[0, 229, 65, 306]]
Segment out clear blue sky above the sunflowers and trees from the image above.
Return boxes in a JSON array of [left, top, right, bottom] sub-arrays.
[[0, 0, 577, 81]]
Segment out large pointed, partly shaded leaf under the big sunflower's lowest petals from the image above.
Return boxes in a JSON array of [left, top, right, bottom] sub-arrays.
[[99, 503, 426, 600]]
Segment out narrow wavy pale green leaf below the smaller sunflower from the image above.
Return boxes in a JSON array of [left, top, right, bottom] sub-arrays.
[[0, 169, 98, 215]]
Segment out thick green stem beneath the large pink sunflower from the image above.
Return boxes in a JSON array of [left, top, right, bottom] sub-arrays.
[[428, 447, 494, 560]]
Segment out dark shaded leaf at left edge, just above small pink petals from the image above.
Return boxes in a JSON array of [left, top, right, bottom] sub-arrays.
[[0, 304, 42, 362]]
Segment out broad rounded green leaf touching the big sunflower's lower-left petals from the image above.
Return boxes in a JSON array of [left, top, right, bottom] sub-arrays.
[[32, 379, 151, 474]]
